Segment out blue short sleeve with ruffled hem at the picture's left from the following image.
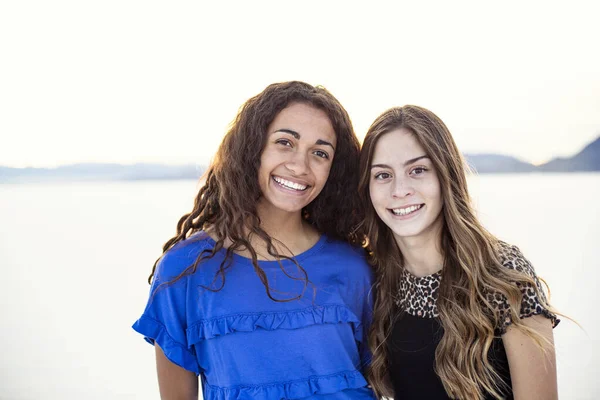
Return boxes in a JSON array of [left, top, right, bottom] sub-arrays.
[[133, 248, 200, 375]]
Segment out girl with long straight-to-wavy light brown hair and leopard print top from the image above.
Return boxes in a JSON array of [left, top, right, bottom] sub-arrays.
[[359, 106, 558, 400]]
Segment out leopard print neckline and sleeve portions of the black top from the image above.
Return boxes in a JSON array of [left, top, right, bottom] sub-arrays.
[[396, 242, 560, 335]]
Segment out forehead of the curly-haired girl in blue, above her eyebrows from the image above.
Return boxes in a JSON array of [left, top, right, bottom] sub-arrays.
[[269, 103, 336, 143]]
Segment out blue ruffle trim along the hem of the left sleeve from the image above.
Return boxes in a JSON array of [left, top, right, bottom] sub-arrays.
[[133, 315, 200, 375]]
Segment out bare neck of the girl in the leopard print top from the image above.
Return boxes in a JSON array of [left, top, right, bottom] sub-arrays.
[[394, 217, 444, 276]]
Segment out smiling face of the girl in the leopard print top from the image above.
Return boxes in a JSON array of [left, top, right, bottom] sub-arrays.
[[369, 128, 444, 242]]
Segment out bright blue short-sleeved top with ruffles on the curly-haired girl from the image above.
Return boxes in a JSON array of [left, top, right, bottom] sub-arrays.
[[133, 233, 374, 400]]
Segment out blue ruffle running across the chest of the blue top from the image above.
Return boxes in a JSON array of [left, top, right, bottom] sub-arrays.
[[186, 304, 363, 346]]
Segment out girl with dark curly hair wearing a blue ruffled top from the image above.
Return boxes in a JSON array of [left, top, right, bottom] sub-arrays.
[[134, 82, 373, 400]]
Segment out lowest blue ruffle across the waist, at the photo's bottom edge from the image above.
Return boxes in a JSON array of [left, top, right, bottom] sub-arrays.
[[202, 371, 367, 400]]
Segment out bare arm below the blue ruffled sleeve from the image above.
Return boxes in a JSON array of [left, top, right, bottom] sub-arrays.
[[154, 343, 198, 400]]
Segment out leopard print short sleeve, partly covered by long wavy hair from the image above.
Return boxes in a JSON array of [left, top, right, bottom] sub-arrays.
[[496, 242, 560, 335]]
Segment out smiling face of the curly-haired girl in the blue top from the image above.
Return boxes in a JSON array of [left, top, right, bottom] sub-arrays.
[[258, 103, 336, 215]]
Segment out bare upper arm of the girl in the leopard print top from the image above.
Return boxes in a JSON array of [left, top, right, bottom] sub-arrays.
[[502, 315, 558, 400]]
